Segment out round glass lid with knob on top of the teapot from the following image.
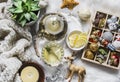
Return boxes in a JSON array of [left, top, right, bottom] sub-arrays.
[[43, 15, 64, 35]]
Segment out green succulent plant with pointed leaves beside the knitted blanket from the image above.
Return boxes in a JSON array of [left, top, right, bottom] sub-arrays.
[[8, 0, 40, 27]]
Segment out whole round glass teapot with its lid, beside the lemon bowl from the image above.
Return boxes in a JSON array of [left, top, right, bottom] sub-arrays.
[[38, 13, 68, 41]]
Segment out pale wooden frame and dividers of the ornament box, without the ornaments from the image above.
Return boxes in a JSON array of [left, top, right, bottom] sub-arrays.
[[81, 11, 120, 69]]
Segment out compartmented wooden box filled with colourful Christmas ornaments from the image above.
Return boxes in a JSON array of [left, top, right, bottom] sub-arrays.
[[81, 11, 120, 69]]
